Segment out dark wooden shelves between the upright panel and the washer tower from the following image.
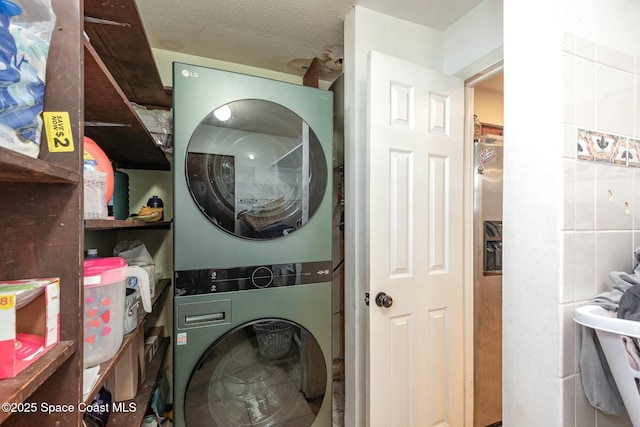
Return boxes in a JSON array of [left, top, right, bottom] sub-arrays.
[[83, 0, 172, 427]]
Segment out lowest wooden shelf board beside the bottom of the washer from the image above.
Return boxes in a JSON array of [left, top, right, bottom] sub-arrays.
[[107, 337, 171, 427]]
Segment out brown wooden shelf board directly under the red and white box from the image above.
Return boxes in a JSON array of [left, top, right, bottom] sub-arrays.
[[0, 341, 77, 423]]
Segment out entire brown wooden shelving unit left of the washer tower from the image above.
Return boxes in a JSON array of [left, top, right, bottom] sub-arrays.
[[0, 0, 171, 427]]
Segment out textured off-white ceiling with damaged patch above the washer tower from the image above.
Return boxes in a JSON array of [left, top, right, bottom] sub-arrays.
[[137, 0, 481, 78]]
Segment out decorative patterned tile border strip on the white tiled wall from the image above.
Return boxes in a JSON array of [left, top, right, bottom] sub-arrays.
[[576, 129, 640, 168]]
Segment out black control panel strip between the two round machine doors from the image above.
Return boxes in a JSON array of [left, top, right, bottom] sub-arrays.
[[174, 261, 332, 296]]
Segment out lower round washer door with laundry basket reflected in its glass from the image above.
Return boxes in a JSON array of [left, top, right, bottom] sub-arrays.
[[184, 319, 327, 427]]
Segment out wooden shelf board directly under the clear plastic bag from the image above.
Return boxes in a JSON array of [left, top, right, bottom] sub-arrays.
[[0, 148, 82, 184]]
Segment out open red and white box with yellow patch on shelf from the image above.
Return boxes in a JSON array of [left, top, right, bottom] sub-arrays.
[[0, 278, 60, 378]]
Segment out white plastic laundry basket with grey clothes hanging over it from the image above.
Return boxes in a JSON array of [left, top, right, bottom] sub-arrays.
[[574, 305, 640, 427]]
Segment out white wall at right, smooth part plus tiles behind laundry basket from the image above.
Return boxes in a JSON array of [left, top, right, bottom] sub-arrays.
[[503, 0, 640, 427]]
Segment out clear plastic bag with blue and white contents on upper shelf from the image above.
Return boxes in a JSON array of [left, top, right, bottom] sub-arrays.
[[0, 0, 55, 158]]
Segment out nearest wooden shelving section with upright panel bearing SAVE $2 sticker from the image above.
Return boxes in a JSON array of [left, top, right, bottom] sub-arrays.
[[0, 0, 83, 426]]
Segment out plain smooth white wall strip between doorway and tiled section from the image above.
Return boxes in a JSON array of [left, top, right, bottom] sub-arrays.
[[503, 1, 570, 427]]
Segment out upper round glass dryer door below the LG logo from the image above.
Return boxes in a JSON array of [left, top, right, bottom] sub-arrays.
[[185, 99, 328, 240]]
